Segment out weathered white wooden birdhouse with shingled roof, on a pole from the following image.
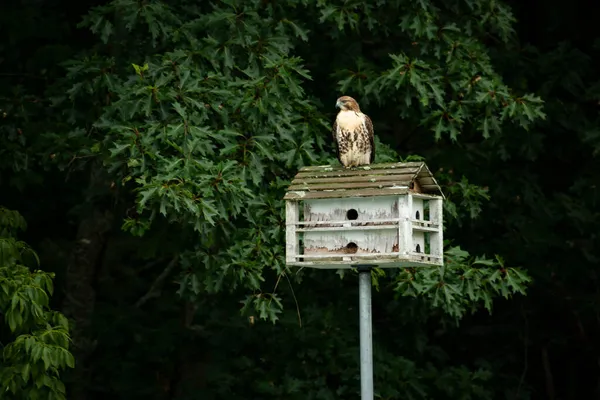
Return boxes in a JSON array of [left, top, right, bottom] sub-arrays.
[[284, 162, 444, 269]]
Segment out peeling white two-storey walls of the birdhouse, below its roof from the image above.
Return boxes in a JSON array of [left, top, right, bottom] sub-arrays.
[[286, 192, 443, 268]]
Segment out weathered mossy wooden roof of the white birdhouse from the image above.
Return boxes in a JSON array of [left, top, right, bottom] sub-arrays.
[[284, 162, 444, 200]]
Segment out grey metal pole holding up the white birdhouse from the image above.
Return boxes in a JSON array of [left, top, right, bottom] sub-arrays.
[[358, 267, 373, 400]]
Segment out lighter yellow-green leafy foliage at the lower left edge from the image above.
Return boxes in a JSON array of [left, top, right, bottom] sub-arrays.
[[0, 208, 74, 400]]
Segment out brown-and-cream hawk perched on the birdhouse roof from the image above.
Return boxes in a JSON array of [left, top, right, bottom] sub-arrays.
[[333, 96, 375, 168]]
